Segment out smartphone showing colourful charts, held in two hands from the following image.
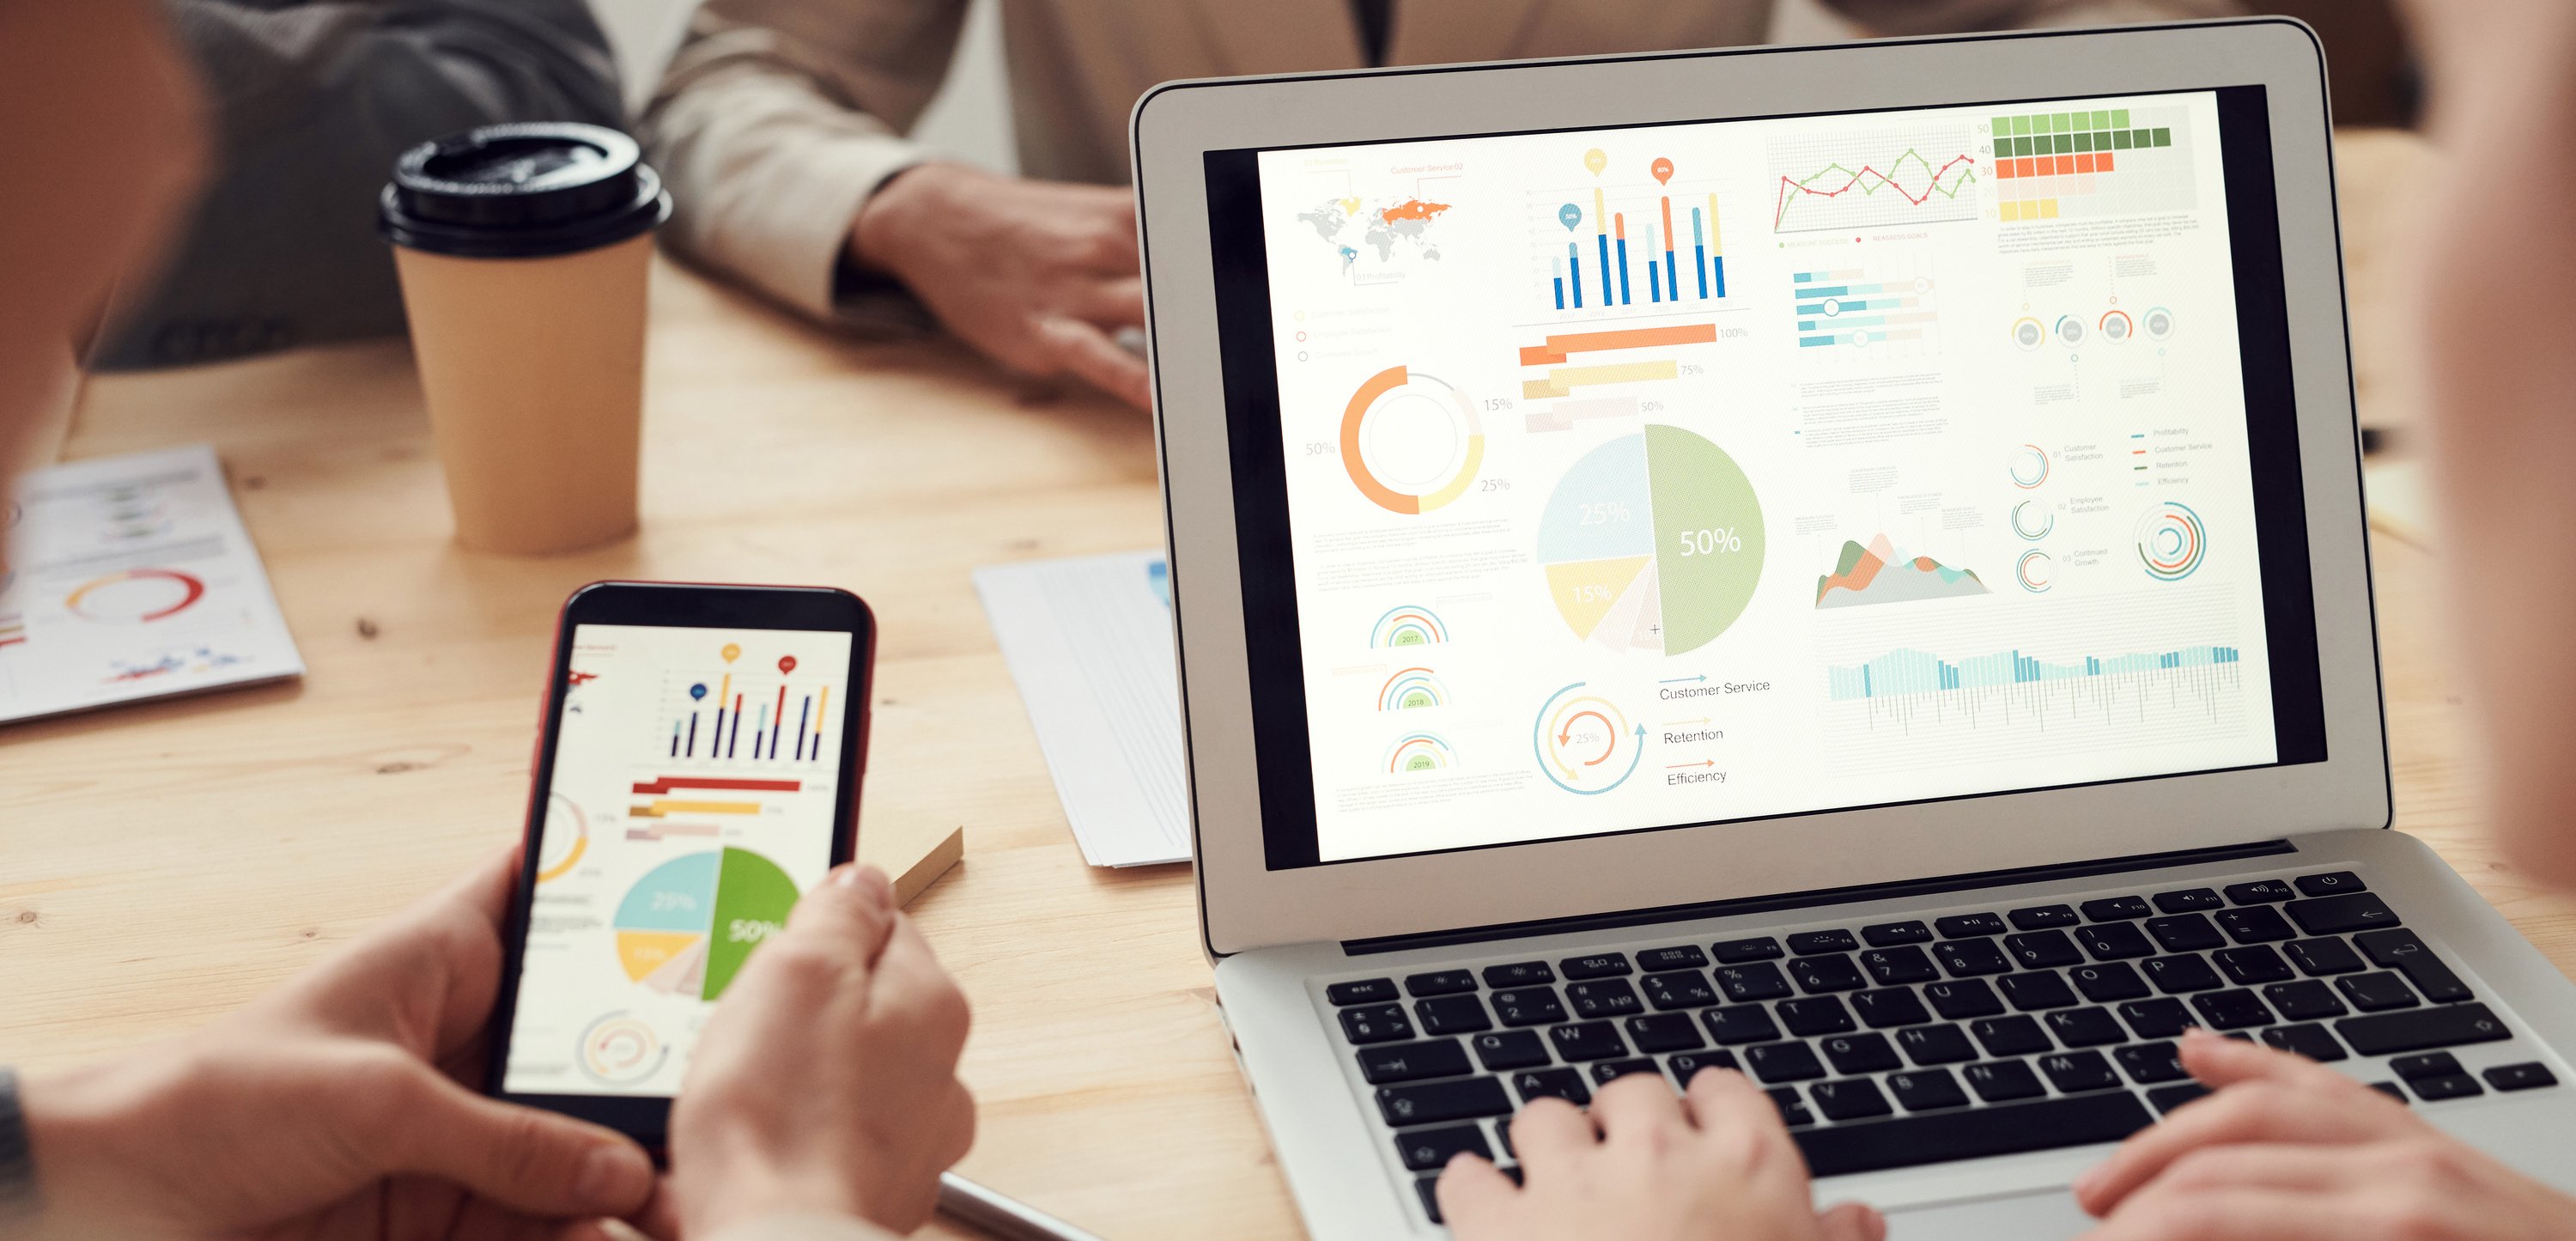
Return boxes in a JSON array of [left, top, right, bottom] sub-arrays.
[[484, 582, 876, 1151]]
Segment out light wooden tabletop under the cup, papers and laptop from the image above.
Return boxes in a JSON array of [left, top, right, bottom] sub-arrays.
[[0, 131, 2576, 1238]]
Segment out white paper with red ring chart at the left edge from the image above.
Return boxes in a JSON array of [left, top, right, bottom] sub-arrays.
[[0, 446, 304, 721]]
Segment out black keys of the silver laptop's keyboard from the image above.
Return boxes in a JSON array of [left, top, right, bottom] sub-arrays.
[[1324, 870, 2558, 1223]]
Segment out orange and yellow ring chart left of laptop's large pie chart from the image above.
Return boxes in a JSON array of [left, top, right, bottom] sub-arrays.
[[1342, 366, 1484, 513]]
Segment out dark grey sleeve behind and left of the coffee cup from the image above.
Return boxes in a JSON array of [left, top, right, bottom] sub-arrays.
[[90, 0, 623, 368]]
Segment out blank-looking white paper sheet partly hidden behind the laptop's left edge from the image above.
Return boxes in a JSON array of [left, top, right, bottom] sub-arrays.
[[974, 551, 1190, 865]]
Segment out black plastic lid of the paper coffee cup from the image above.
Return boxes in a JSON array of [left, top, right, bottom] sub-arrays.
[[376, 121, 670, 258]]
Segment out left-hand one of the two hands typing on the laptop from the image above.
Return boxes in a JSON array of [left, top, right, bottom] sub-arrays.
[[1440, 1068, 1888, 1241]]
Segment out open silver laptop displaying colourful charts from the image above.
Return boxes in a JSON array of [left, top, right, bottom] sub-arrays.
[[1133, 21, 2576, 1238]]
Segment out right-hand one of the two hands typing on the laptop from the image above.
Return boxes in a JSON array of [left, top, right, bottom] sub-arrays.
[[2074, 1030, 2576, 1241]]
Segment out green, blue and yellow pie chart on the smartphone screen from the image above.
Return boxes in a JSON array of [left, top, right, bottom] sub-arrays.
[[611, 849, 796, 999]]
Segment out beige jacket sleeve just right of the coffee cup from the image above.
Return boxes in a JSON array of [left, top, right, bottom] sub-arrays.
[[644, 0, 966, 319]]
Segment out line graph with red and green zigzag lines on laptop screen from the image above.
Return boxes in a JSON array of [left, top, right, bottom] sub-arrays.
[[1770, 129, 1984, 234]]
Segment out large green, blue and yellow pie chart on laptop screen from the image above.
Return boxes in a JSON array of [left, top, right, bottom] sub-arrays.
[[1538, 425, 1762, 654]]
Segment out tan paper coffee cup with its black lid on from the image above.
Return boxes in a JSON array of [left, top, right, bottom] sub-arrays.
[[376, 124, 670, 557]]
